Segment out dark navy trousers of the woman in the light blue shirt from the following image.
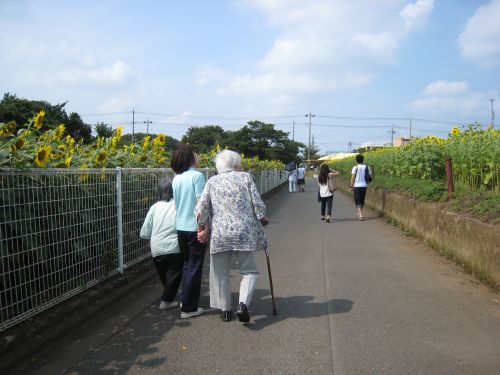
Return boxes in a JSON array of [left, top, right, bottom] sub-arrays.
[[177, 230, 206, 312]]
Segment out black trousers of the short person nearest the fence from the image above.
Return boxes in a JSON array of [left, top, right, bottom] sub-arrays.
[[153, 254, 182, 302]]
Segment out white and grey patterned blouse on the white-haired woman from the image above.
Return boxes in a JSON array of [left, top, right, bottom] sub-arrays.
[[195, 171, 268, 254]]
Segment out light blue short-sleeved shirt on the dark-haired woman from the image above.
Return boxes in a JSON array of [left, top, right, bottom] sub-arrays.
[[172, 167, 205, 232]]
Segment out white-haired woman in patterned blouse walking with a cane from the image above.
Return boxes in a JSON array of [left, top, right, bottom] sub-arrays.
[[196, 150, 268, 323]]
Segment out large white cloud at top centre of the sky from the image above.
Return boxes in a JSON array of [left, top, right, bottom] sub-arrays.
[[218, 0, 434, 103]]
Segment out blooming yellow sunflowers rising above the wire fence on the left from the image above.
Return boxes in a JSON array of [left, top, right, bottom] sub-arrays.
[[0, 111, 284, 171]]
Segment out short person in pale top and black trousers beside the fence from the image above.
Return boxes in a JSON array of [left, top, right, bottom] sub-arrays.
[[139, 177, 183, 310]]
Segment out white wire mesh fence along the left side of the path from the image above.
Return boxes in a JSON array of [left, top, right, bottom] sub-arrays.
[[0, 168, 286, 331]]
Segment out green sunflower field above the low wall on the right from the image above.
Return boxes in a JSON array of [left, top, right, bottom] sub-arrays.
[[330, 124, 500, 222]]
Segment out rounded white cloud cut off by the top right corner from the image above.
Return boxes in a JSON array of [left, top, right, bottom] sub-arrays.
[[458, 0, 500, 67]]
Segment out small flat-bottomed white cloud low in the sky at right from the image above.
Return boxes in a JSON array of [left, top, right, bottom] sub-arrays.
[[411, 80, 486, 115]]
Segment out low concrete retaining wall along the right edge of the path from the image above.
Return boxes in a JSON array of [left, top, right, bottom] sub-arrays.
[[338, 179, 500, 287]]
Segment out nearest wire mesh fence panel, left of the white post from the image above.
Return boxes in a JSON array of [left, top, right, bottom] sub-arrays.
[[0, 170, 117, 330]]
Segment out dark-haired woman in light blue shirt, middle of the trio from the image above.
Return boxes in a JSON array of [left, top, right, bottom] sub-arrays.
[[170, 145, 206, 319]]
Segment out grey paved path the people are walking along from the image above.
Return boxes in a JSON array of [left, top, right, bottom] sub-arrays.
[[10, 180, 500, 375]]
